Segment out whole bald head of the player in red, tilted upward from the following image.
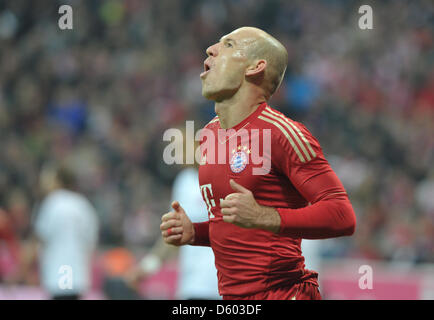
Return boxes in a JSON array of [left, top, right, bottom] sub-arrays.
[[201, 27, 288, 101]]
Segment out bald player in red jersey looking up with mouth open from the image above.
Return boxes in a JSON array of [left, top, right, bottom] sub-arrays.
[[160, 27, 356, 300]]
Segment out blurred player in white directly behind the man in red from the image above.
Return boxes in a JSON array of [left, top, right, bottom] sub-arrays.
[[126, 129, 221, 300]]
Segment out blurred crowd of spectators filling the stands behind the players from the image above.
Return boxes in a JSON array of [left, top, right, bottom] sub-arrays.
[[0, 0, 434, 288]]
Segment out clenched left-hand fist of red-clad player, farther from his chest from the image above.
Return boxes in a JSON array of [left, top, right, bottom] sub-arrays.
[[160, 201, 194, 246]]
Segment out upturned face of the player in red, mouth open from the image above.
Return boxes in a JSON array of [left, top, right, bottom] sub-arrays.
[[200, 30, 251, 101]]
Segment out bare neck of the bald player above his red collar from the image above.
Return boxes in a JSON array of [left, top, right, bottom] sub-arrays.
[[215, 87, 266, 129]]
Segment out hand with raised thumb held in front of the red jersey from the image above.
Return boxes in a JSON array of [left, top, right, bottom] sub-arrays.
[[220, 179, 280, 233]]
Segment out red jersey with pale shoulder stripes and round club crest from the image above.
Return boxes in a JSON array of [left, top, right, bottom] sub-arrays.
[[195, 103, 345, 296]]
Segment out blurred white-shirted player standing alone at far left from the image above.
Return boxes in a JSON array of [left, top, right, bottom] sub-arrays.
[[22, 168, 98, 299]]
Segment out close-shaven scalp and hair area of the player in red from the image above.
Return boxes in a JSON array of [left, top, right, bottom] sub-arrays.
[[232, 27, 288, 98]]
